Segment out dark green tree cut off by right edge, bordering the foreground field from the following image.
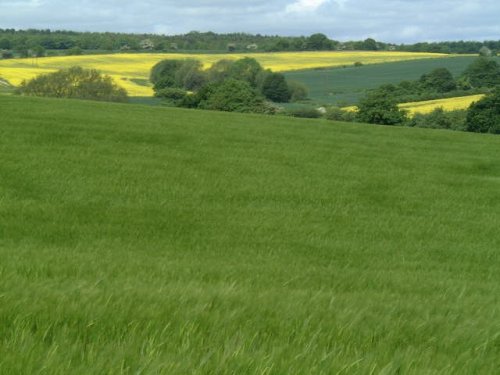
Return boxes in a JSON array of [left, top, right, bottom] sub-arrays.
[[466, 87, 500, 134]]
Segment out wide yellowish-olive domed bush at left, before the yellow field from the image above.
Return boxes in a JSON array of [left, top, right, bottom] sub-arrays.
[[19, 66, 127, 102]]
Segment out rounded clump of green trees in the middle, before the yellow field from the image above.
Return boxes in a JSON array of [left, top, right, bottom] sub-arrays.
[[150, 57, 307, 113]]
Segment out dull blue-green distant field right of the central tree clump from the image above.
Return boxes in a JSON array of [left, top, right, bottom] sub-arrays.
[[285, 56, 500, 106]]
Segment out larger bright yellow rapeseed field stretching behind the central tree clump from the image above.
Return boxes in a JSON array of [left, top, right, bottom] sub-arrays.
[[0, 51, 450, 96]]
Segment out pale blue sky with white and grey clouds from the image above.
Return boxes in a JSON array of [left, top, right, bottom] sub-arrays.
[[0, 0, 500, 43]]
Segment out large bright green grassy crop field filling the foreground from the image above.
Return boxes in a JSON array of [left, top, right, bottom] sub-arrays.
[[0, 96, 500, 374]]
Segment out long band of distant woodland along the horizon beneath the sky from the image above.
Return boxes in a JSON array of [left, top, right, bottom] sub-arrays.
[[0, 28, 500, 58]]
